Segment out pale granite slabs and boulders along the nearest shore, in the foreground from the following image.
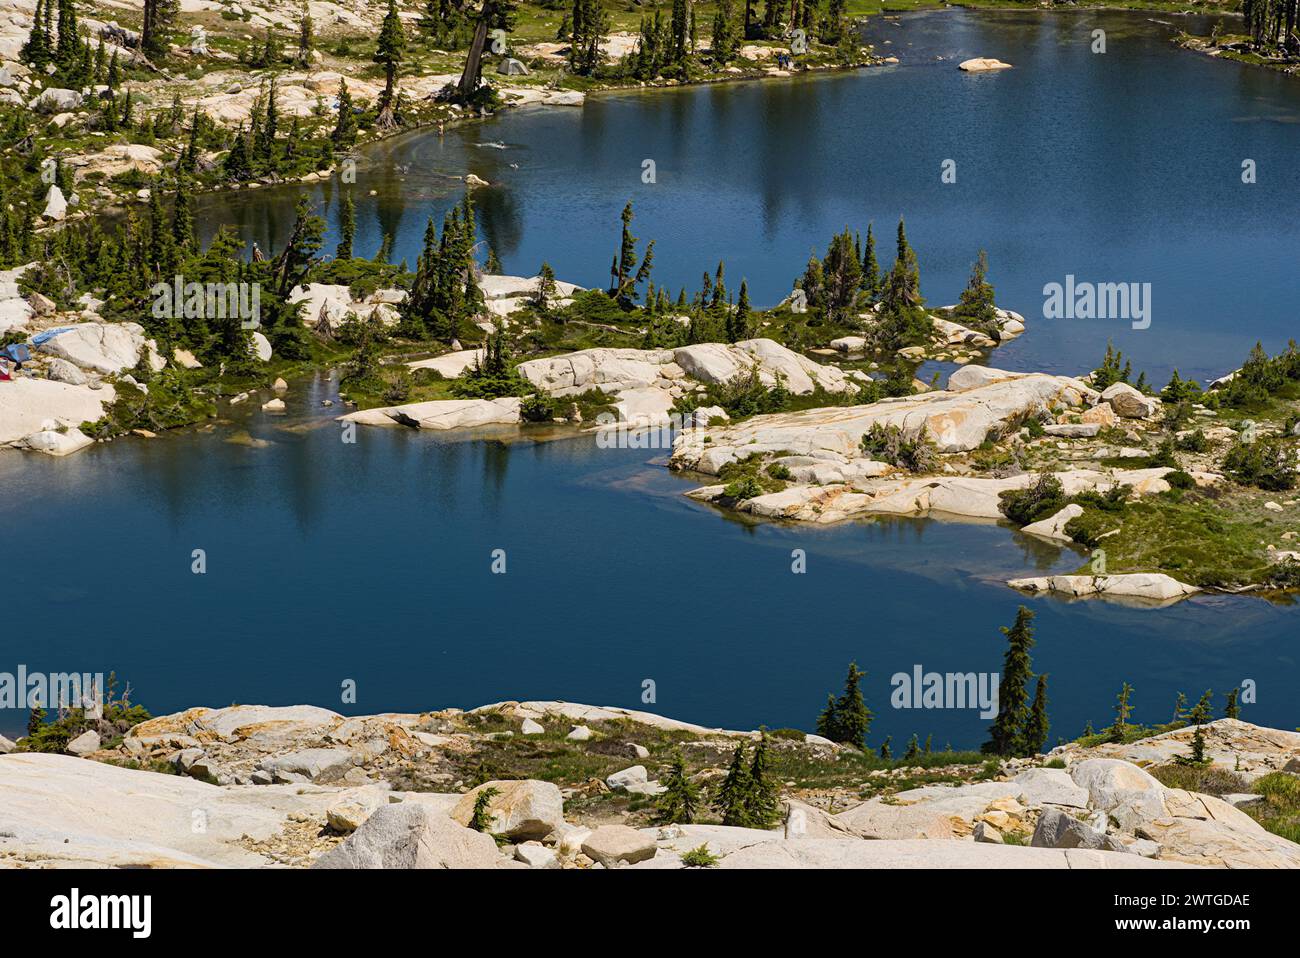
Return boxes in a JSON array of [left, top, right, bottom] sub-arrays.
[[0, 702, 1300, 870]]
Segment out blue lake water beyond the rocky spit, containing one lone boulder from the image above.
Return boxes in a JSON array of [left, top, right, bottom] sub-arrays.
[[197, 10, 1300, 383]]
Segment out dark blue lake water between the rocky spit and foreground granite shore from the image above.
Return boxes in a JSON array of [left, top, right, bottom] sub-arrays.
[[0, 382, 1300, 745]]
